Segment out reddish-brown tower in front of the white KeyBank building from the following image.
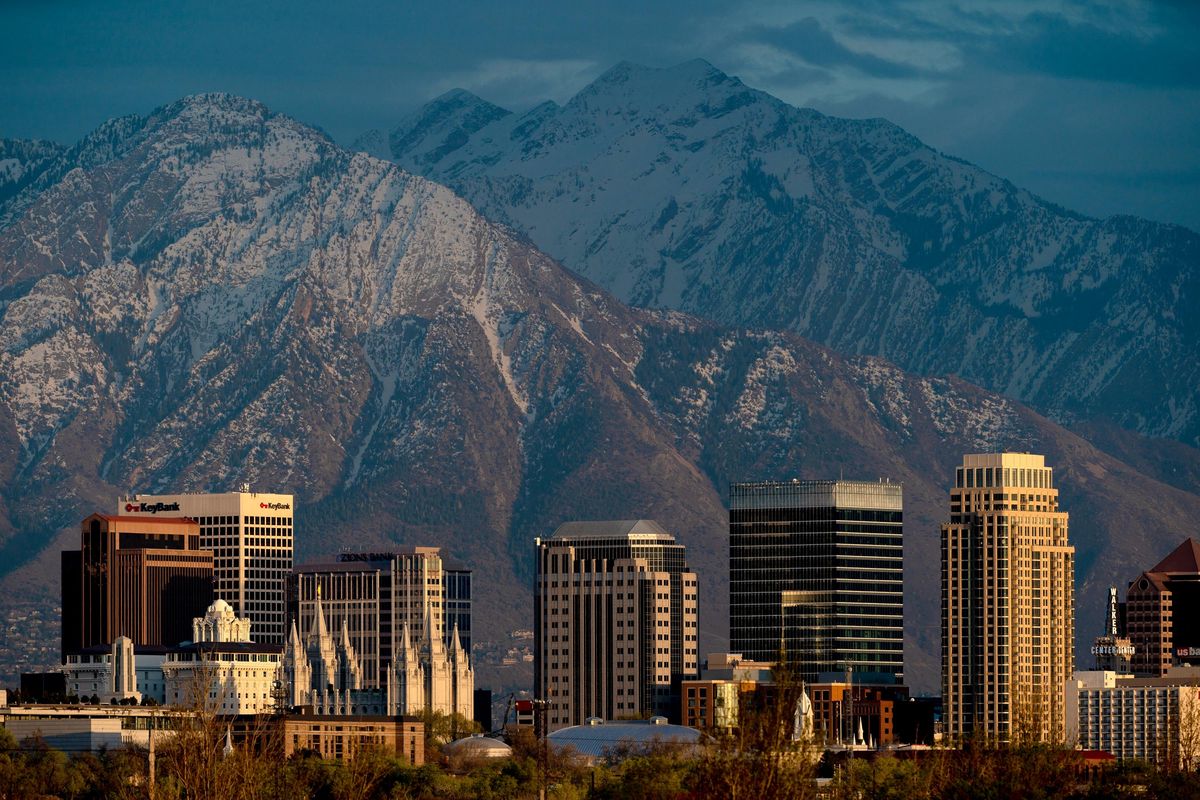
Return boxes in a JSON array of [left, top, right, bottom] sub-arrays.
[[62, 513, 212, 656]]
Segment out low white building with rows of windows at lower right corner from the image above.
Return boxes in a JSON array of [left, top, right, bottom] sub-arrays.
[[1063, 667, 1200, 771]]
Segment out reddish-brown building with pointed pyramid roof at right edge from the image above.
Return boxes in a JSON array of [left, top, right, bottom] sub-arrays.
[[1126, 539, 1200, 676]]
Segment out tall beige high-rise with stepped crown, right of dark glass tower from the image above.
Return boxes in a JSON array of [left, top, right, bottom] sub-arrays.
[[942, 453, 1075, 740]]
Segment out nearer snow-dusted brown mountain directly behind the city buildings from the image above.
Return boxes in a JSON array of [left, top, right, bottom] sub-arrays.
[[0, 95, 1200, 688]]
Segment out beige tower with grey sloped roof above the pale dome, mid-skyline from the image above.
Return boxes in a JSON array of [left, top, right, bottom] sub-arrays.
[[534, 519, 698, 730]]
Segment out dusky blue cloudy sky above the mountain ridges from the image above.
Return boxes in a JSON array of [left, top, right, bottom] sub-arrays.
[[7, 0, 1200, 230]]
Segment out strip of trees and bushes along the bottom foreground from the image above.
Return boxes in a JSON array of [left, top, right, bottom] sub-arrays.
[[0, 727, 1200, 800]]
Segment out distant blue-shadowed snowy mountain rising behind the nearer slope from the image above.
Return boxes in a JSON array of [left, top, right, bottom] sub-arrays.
[[381, 61, 1200, 446]]
